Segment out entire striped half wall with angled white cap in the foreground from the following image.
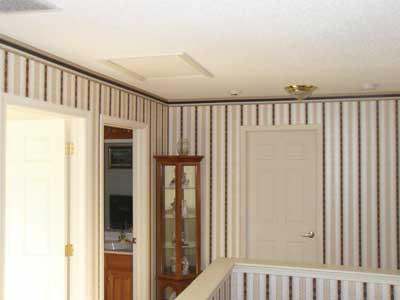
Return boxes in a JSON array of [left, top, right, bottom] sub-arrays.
[[177, 258, 400, 300]]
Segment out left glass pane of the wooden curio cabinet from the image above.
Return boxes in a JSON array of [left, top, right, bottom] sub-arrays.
[[161, 165, 176, 274]]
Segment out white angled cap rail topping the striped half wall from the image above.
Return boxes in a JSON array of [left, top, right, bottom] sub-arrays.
[[176, 258, 400, 300]]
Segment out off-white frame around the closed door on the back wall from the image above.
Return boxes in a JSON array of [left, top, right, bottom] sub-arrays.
[[239, 124, 323, 264]]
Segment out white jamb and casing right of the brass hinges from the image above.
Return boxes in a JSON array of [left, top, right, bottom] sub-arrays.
[[66, 118, 94, 300]]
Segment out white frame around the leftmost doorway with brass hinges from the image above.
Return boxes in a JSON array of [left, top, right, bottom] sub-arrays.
[[0, 92, 95, 300]]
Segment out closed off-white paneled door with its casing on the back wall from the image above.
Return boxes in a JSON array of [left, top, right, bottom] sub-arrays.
[[240, 125, 322, 263]]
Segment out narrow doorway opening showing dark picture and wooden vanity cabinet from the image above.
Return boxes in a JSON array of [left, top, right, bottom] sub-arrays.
[[103, 126, 135, 300]]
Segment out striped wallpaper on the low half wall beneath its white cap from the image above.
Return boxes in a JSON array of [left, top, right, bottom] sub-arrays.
[[231, 271, 400, 300]]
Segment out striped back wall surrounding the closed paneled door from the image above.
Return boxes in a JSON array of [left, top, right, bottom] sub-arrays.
[[169, 100, 400, 269]]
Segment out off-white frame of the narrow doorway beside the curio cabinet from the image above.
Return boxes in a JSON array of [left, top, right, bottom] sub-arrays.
[[97, 116, 151, 300]]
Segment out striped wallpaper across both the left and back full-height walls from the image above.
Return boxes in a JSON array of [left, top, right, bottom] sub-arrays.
[[0, 39, 400, 290]]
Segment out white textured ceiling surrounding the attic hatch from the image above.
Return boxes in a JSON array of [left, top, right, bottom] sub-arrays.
[[0, 0, 400, 100]]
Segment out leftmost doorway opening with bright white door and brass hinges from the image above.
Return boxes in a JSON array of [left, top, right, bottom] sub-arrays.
[[2, 105, 93, 300]]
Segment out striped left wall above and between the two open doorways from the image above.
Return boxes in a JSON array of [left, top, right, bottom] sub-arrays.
[[0, 45, 169, 298]]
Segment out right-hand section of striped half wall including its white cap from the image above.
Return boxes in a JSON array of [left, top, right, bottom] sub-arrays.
[[230, 260, 400, 300]]
